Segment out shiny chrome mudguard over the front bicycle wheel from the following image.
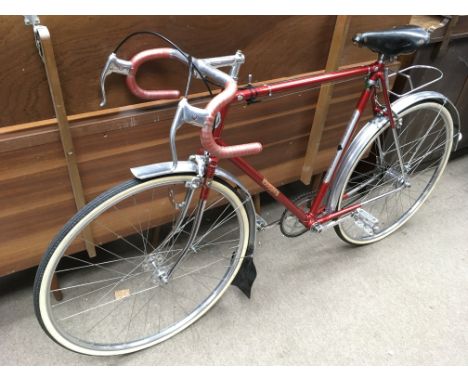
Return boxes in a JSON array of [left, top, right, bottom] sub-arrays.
[[130, 160, 257, 256]]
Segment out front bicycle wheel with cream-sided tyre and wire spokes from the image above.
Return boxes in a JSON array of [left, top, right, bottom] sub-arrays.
[[34, 175, 249, 355]]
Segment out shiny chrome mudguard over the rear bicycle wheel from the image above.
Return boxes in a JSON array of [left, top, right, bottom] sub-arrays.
[[327, 91, 462, 211]]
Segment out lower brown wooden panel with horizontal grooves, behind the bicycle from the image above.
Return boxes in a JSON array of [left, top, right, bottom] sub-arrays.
[[0, 77, 362, 274]]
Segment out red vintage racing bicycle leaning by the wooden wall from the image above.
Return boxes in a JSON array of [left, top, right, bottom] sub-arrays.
[[34, 26, 461, 355]]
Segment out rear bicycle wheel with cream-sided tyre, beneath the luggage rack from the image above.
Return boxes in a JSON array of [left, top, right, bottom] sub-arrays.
[[335, 101, 453, 245]]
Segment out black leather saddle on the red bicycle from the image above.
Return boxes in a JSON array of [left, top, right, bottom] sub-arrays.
[[353, 25, 430, 57]]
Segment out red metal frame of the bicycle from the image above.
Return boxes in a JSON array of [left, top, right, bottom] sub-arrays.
[[207, 61, 394, 229]]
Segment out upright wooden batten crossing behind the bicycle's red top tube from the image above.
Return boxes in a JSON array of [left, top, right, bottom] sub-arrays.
[[301, 16, 351, 184]]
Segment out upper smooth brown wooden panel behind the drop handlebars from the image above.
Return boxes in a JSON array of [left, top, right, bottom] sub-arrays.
[[0, 16, 335, 126]]
